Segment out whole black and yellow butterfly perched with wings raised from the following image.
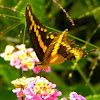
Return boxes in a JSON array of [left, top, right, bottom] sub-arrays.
[[25, 4, 87, 68]]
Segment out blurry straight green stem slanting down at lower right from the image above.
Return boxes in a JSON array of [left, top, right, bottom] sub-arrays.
[[76, 62, 96, 94]]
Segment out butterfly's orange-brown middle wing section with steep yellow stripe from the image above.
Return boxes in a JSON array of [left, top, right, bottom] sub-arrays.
[[43, 30, 65, 65]]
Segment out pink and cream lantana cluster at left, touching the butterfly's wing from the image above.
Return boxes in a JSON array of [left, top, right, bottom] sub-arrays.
[[0, 44, 51, 74]]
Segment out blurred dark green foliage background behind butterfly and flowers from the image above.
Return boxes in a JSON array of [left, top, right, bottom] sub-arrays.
[[0, 0, 100, 100]]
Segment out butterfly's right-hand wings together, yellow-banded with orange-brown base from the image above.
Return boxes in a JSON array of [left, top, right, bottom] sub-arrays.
[[44, 30, 87, 65]]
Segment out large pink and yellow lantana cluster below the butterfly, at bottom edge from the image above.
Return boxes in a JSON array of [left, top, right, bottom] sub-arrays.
[[12, 76, 62, 100]]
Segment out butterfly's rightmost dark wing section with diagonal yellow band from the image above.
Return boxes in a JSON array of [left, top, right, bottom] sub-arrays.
[[58, 31, 87, 60]]
